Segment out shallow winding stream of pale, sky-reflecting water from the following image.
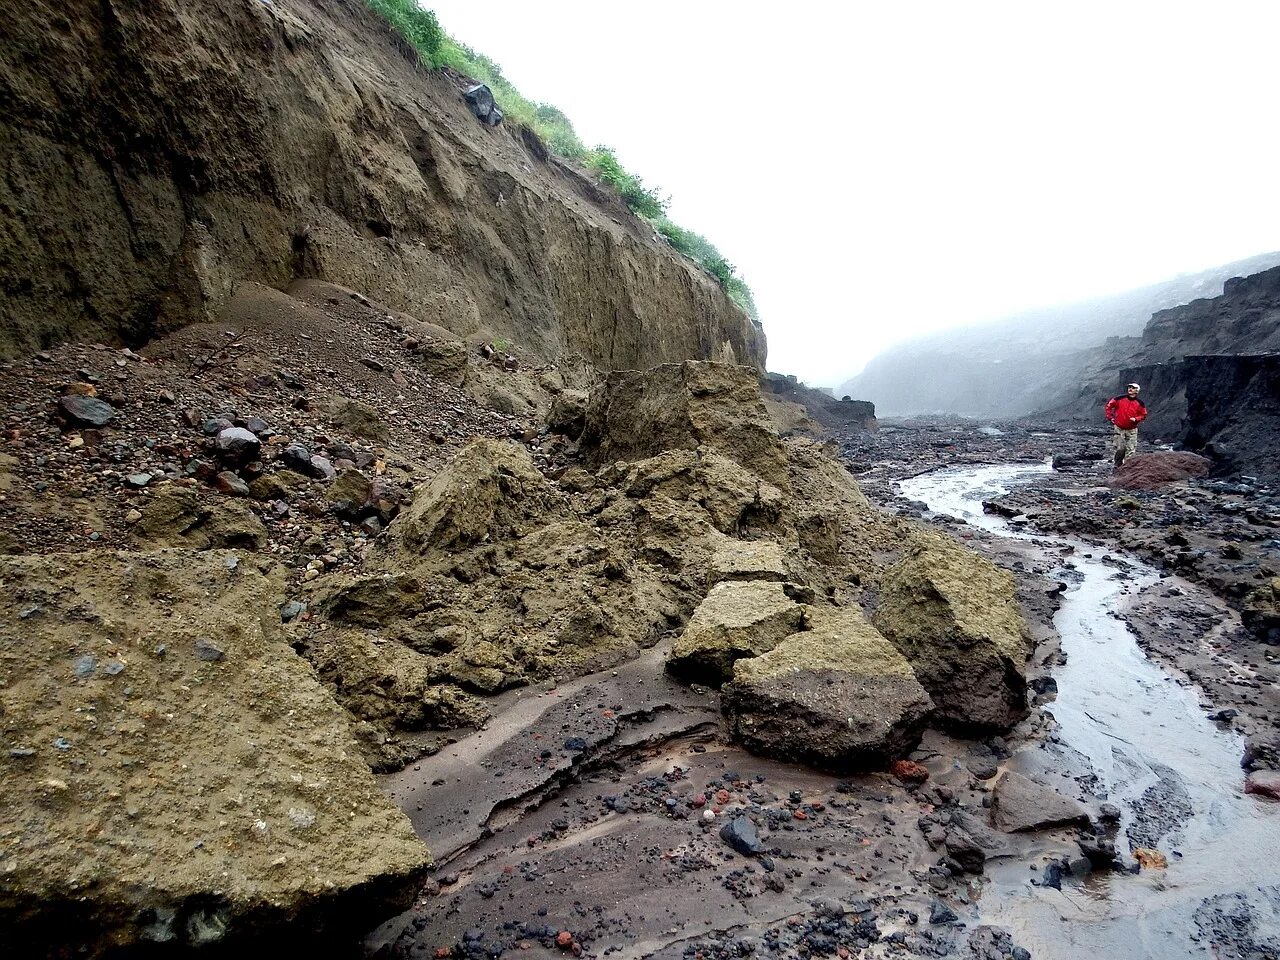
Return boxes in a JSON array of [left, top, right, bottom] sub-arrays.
[[900, 465, 1280, 960]]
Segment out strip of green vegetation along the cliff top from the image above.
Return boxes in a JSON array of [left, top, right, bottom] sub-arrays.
[[366, 0, 760, 324]]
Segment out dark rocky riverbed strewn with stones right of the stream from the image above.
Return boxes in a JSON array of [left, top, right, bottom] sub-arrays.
[[844, 420, 1280, 769]]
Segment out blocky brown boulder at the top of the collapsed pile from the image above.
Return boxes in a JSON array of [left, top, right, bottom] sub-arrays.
[[581, 360, 790, 490]]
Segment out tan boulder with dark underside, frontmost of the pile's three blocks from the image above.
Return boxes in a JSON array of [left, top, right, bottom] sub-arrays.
[[722, 607, 932, 772]]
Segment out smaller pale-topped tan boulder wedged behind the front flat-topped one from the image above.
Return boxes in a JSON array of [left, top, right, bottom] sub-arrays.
[[667, 580, 804, 686]]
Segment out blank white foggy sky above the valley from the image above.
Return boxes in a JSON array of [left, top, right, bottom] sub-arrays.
[[421, 0, 1280, 385]]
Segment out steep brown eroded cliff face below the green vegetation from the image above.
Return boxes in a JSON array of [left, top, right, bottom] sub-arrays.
[[0, 0, 765, 370]]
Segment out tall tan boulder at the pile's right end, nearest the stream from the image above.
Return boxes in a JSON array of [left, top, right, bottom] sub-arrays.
[[873, 534, 1030, 732]]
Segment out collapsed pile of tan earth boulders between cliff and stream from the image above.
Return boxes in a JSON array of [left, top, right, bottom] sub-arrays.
[[301, 361, 1029, 771]]
